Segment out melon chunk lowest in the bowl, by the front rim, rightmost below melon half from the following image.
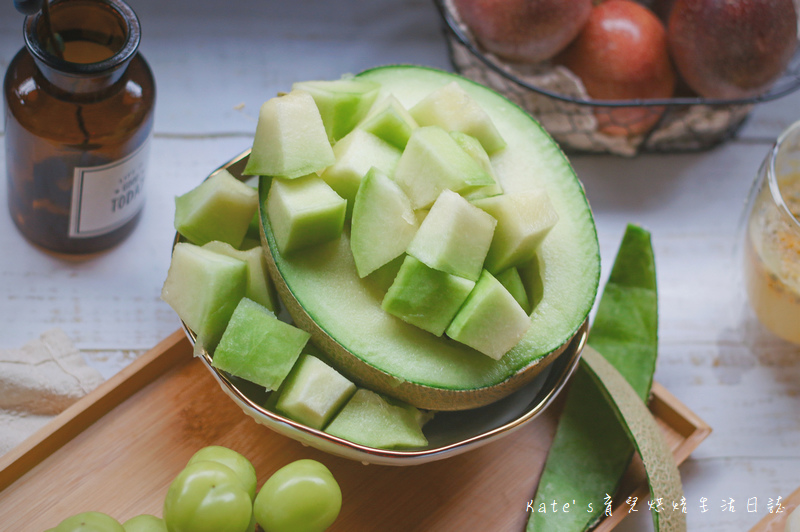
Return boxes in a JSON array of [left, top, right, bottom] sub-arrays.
[[325, 388, 428, 449]]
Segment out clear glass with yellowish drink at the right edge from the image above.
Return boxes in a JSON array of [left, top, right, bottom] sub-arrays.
[[744, 122, 800, 344]]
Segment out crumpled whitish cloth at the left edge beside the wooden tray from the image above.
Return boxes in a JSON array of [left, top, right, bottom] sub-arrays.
[[0, 329, 103, 455]]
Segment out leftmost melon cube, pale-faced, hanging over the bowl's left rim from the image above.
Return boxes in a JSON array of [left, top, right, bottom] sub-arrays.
[[161, 242, 247, 352]]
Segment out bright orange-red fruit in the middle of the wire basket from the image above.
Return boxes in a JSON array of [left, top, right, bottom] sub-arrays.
[[557, 0, 676, 135]]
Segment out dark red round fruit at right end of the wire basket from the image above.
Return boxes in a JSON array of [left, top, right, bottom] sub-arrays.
[[668, 0, 797, 98]]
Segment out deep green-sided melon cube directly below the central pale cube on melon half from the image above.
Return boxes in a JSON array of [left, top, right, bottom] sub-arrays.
[[381, 255, 475, 336]]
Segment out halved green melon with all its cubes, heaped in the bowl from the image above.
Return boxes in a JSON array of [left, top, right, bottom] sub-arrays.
[[162, 66, 599, 448]]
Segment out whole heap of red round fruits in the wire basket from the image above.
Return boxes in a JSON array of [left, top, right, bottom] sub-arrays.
[[452, 0, 797, 135]]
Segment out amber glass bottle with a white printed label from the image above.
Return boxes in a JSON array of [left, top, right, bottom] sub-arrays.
[[3, 0, 155, 253]]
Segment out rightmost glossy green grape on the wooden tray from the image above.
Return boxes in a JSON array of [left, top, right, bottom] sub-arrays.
[[253, 459, 342, 532]]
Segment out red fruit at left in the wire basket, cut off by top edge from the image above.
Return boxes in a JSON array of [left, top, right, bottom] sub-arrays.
[[453, 0, 592, 63]]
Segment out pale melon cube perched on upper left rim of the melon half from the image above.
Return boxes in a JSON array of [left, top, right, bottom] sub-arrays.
[[244, 90, 336, 179]]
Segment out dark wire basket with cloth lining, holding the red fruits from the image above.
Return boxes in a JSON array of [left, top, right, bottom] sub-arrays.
[[433, 0, 800, 156]]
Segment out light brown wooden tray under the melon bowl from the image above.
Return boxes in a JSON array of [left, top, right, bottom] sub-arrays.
[[0, 331, 711, 532]]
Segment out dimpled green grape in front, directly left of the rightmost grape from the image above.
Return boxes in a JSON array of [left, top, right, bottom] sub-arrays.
[[163, 460, 253, 532]]
